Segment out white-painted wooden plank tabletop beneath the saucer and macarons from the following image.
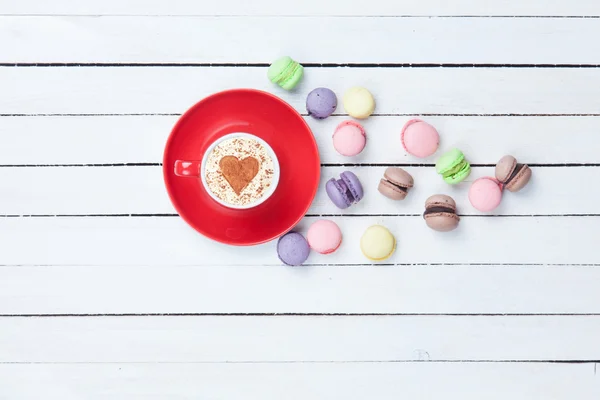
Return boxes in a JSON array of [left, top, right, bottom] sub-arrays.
[[0, 0, 600, 400]]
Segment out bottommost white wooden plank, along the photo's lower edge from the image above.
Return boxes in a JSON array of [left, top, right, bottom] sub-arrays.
[[0, 362, 600, 400]]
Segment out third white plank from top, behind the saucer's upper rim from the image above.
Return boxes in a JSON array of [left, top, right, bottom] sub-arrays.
[[0, 67, 600, 115]]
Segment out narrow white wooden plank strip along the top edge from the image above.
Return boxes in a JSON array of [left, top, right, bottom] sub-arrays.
[[0, 0, 600, 16]]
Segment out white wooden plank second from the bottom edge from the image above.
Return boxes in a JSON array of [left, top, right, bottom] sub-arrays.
[[0, 316, 600, 363]]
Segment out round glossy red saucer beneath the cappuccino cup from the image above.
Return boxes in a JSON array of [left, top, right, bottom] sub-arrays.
[[163, 89, 320, 246]]
